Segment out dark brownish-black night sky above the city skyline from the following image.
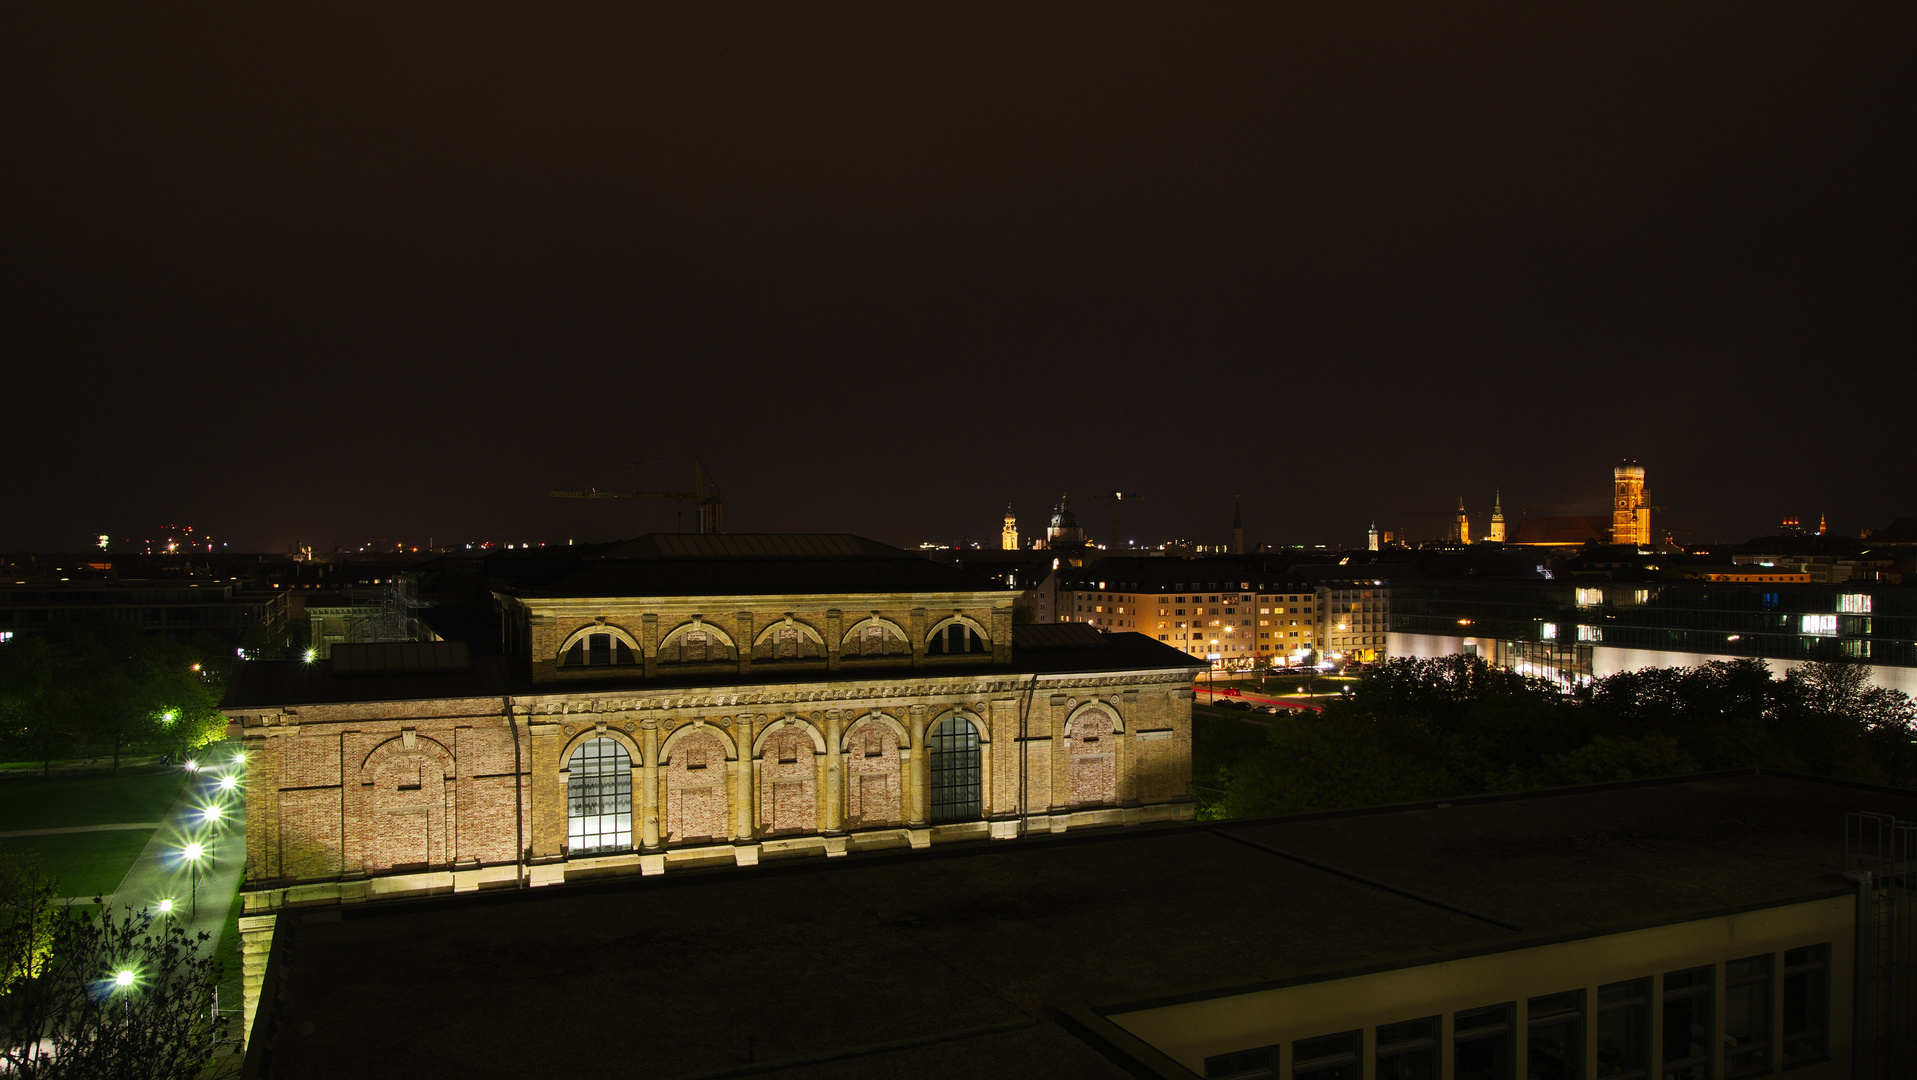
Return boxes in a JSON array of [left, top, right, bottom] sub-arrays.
[[0, 2, 1917, 549]]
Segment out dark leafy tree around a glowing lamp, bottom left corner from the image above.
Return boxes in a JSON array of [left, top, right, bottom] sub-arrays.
[[0, 888, 220, 1080]]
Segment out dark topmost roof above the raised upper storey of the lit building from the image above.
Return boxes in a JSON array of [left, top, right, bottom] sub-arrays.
[[487, 533, 1003, 599]]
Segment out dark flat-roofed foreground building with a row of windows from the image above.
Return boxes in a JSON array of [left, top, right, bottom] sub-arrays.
[[245, 771, 1917, 1080]]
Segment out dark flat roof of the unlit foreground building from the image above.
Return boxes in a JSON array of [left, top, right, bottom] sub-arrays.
[[253, 773, 1917, 1080]]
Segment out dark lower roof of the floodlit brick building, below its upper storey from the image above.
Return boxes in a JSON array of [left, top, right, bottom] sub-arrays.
[[220, 623, 1206, 710]]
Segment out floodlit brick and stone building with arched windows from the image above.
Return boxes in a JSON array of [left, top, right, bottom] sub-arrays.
[[222, 535, 1202, 1043]]
